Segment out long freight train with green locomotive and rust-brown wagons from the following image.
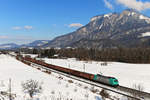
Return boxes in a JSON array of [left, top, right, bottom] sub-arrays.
[[16, 56, 119, 87]]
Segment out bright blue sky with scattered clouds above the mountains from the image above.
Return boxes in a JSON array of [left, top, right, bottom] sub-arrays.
[[0, 0, 150, 44]]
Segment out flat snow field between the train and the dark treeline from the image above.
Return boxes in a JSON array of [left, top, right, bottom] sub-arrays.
[[44, 58, 150, 93]]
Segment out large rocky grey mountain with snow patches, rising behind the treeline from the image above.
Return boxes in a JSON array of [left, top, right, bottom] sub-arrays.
[[45, 10, 150, 48]]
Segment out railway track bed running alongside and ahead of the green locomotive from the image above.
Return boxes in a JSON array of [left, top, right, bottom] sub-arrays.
[[22, 61, 150, 100]]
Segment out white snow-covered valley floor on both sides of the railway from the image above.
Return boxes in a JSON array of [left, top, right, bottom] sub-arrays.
[[0, 55, 150, 100]]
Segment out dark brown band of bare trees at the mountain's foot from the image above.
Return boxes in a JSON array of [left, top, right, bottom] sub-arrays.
[[18, 48, 150, 63]]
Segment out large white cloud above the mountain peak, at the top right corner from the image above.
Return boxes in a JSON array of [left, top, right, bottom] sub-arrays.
[[117, 0, 150, 11]]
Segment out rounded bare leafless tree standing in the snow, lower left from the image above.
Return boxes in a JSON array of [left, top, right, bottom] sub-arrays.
[[21, 79, 42, 98]]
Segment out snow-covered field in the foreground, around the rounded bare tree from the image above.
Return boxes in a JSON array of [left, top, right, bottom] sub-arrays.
[[0, 55, 109, 100]]
